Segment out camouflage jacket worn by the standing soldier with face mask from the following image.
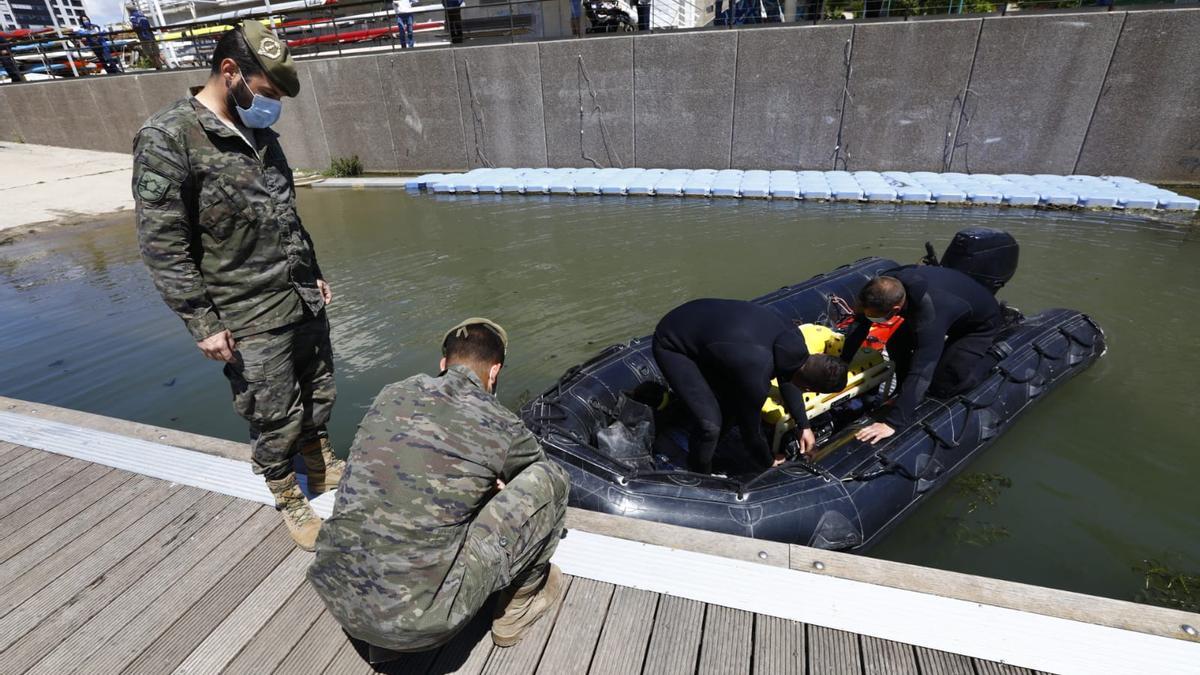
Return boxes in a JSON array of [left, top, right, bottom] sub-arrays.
[[133, 91, 324, 341]]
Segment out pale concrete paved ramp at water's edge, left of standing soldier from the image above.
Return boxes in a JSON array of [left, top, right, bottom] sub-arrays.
[[0, 143, 133, 229]]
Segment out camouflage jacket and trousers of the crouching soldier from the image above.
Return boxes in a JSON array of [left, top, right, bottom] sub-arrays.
[[308, 365, 568, 651]]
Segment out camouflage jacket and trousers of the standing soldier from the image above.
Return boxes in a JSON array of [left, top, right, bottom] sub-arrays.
[[133, 90, 336, 479]]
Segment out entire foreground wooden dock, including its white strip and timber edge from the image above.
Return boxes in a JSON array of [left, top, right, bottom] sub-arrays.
[[0, 399, 1200, 675]]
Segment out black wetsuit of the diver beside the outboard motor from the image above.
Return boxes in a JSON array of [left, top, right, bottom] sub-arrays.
[[841, 265, 1002, 428]]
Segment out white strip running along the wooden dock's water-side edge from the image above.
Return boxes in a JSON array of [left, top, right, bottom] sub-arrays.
[[0, 412, 1200, 674]]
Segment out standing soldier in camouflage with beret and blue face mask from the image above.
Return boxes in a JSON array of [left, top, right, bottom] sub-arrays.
[[133, 22, 346, 550]]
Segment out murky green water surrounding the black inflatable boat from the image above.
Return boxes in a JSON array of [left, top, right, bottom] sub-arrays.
[[0, 190, 1200, 598]]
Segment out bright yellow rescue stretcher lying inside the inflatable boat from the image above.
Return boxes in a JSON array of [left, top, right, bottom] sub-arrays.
[[762, 323, 892, 453]]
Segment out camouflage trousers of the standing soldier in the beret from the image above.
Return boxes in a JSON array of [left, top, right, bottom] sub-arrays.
[[224, 312, 337, 480]]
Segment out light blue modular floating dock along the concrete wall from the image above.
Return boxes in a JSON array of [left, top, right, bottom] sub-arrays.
[[350, 168, 1200, 211]]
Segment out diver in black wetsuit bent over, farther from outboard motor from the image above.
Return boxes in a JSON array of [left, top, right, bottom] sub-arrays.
[[654, 299, 846, 473]]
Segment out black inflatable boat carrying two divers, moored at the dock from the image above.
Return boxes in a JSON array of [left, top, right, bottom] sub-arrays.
[[521, 233, 1105, 551]]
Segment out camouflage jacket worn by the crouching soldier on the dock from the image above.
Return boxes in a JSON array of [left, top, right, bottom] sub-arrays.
[[308, 365, 545, 644]]
